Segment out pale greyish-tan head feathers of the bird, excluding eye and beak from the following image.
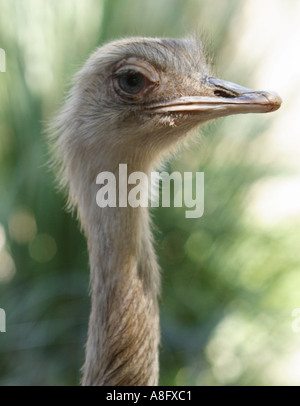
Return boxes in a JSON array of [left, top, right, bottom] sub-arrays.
[[50, 37, 208, 216]]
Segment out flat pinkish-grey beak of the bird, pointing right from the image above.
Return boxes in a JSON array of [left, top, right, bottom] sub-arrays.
[[148, 77, 282, 119]]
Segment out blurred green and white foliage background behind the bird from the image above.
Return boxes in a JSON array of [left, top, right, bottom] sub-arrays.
[[0, 0, 300, 386]]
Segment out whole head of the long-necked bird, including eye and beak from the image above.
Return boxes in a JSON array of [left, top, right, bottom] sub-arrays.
[[57, 38, 281, 213]]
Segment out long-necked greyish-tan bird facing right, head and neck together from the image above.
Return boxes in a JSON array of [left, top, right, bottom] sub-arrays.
[[52, 38, 281, 386]]
